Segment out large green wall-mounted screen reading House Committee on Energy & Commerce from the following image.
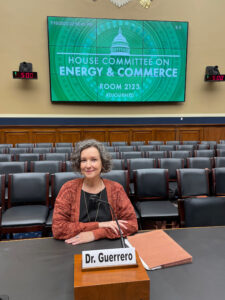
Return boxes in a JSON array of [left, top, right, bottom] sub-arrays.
[[48, 17, 188, 103]]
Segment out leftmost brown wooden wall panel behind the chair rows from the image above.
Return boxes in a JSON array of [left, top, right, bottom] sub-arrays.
[[3, 128, 32, 145]]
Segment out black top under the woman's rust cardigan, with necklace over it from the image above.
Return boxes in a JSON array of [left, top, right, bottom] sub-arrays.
[[79, 188, 112, 223]]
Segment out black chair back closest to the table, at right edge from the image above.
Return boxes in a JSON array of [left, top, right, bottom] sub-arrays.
[[178, 197, 225, 227]]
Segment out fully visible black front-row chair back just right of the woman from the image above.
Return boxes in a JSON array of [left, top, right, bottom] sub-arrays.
[[134, 168, 169, 200]]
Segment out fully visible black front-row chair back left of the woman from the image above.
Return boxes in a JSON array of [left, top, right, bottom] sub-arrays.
[[8, 173, 49, 207]]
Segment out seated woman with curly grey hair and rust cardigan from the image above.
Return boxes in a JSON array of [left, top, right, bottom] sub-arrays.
[[52, 140, 138, 245]]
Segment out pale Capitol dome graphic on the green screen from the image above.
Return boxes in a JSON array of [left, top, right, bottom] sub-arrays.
[[110, 28, 130, 56]]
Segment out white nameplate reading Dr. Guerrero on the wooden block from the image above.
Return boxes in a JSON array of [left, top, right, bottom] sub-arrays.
[[82, 248, 137, 269]]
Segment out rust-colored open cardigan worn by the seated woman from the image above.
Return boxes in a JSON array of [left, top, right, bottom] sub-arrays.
[[52, 178, 138, 240]]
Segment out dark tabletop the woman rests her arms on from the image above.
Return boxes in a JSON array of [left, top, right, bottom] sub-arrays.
[[0, 227, 225, 300]]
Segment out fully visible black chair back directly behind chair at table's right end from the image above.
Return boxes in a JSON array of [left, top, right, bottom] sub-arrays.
[[177, 168, 210, 198]]
